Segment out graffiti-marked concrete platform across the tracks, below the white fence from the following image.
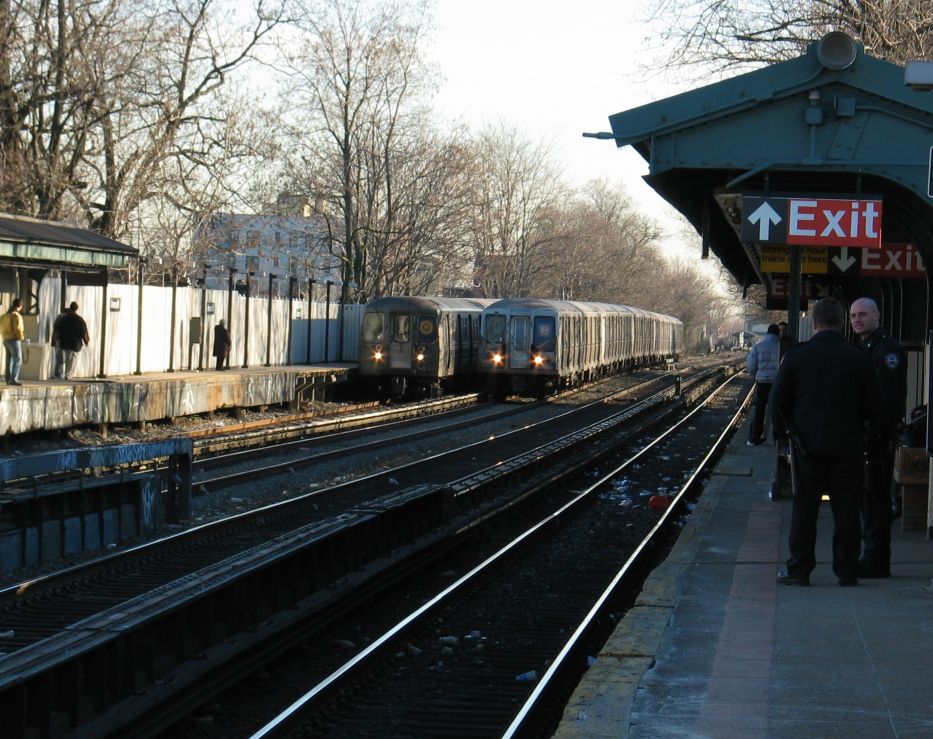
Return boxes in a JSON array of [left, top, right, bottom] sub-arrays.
[[0, 362, 357, 435]]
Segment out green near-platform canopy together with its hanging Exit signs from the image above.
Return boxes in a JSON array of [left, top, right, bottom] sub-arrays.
[[597, 32, 933, 339]]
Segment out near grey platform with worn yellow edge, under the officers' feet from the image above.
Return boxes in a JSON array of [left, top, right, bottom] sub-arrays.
[[554, 420, 933, 739]]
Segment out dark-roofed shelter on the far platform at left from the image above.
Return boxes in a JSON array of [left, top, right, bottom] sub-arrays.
[[0, 213, 139, 373]]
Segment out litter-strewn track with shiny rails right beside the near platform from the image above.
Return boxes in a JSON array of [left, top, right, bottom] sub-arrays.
[[246, 368, 749, 739]]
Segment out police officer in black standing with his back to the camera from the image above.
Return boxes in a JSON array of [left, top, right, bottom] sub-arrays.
[[772, 298, 880, 585]]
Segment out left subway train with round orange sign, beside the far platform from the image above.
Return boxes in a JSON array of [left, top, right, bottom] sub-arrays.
[[359, 297, 494, 398]]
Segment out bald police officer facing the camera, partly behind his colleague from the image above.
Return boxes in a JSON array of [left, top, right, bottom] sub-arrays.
[[849, 298, 907, 577]]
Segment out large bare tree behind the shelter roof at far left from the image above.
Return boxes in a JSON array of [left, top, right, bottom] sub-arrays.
[[0, 0, 281, 237]]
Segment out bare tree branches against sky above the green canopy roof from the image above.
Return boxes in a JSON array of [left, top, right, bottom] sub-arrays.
[[653, 0, 933, 71]]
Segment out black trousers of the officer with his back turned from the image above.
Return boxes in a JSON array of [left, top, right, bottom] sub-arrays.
[[787, 454, 864, 577]]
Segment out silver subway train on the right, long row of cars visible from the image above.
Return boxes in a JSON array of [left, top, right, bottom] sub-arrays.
[[479, 298, 684, 398]]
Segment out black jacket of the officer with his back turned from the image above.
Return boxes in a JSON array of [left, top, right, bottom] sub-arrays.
[[771, 330, 880, 456]]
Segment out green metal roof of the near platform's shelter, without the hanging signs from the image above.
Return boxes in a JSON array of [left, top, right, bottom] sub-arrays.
[[598, 34, 933, 320]]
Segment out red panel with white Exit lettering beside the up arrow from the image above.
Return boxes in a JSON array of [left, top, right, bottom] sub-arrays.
[[787, 198, 881, 249]]
